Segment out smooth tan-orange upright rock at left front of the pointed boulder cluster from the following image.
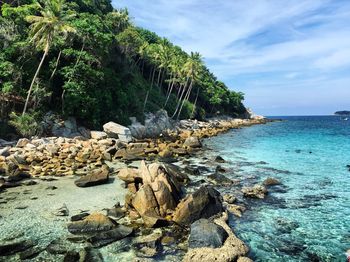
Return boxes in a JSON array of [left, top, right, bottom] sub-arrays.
[[132, 184, 160, 217]]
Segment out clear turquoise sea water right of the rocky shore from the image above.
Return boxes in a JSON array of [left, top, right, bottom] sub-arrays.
[[207, 116, 350, 261]]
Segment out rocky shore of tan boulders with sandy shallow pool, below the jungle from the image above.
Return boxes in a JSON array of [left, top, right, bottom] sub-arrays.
[[0, 112, 270, 262]]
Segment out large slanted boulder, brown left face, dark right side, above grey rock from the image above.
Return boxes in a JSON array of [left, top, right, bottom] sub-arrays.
[[173, 186, 223, 225]]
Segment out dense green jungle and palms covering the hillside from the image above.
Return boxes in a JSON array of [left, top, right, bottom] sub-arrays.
[[0, 0, 245, 135]]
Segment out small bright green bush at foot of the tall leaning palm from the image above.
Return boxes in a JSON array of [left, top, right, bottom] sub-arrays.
[[9, 112, 39, 137]]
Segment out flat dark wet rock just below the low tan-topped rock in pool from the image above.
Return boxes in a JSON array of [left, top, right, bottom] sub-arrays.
[[88, 225, 133, 247]]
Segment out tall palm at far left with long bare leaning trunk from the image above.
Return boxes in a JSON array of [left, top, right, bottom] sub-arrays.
[[22, 0, 75, 115]]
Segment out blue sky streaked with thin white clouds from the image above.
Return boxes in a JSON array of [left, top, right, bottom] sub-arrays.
[[112, 0, 350, 116]]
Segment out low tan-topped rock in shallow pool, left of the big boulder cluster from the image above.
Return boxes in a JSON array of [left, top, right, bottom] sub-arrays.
[[68, 213, 116, 234]]
